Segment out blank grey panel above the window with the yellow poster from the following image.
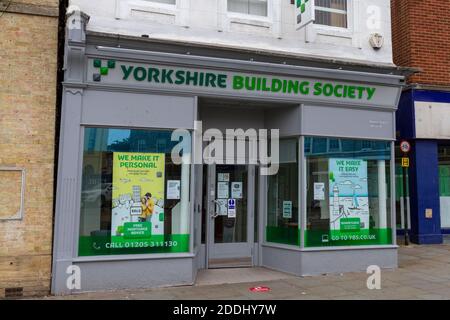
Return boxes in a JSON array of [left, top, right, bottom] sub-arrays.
[[81, 90, 196, 129]]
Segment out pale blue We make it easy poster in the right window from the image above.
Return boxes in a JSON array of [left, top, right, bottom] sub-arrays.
[[329, 159, 370, 240]]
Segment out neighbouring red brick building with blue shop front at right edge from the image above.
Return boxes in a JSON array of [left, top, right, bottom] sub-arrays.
[[391, 0, 450, 244]]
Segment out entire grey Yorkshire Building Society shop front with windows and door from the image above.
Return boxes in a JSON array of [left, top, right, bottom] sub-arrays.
[[52, 20, 403, 294]]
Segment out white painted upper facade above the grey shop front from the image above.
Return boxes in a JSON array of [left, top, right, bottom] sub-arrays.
[[70, 0, 393, 65]]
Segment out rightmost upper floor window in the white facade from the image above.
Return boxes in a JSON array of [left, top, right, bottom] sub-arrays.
[[315, 0, 348, 28]]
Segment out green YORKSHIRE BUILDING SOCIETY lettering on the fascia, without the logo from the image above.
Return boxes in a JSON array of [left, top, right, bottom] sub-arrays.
[[120, 65, 376, 101]]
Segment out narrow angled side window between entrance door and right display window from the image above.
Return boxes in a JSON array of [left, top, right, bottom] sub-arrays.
[[266, 139, 300, 246]]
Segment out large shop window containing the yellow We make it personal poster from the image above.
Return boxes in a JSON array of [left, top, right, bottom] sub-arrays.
[[78, 128, 190, 256]]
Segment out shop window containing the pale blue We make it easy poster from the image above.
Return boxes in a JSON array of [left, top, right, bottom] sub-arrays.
[[305, 137, 392, 247]]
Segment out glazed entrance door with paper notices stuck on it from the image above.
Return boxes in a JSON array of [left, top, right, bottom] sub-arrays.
[[207, 165, 255, 268]]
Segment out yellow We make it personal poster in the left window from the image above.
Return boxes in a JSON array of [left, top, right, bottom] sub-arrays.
[[111, 152, 165, 247]]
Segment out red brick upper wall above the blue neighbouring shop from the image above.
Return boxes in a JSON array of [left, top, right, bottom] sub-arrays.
[[391, 0, 450, 86]]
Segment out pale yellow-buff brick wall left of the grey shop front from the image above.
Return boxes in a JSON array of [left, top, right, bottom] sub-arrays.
[[0, 0, 58, 297]]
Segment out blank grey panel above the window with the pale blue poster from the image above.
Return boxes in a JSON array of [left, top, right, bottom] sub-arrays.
[[301, 105, 395, 140]]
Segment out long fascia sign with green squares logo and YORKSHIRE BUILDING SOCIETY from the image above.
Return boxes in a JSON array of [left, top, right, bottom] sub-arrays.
[[87, 59, 398, 107]]
